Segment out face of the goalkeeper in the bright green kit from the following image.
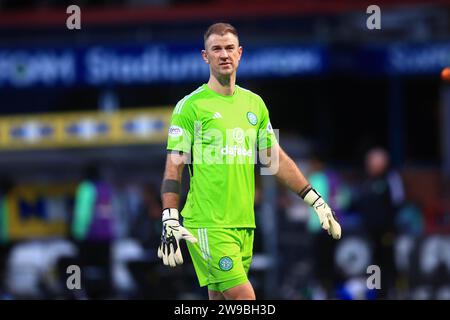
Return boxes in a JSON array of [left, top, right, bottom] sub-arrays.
[[202, 33, 242, 76]]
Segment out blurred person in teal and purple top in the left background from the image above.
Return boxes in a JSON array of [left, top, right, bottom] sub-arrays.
[[72, 165, 117, 299]]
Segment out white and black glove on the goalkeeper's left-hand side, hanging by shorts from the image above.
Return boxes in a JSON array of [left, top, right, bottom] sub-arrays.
[[158, 208, 197, 267]]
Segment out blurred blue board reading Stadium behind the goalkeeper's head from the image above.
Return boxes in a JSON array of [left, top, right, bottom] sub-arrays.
[[0, 44, 326, 88]]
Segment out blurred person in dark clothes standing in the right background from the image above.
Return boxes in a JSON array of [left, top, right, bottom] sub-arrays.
[[356, 148, 404, 298]]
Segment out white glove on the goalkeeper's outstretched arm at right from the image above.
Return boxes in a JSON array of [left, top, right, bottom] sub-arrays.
[[302, 188, 342, 239]]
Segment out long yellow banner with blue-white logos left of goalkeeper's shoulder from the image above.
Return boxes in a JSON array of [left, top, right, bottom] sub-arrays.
[[0, 107, 173, 151]]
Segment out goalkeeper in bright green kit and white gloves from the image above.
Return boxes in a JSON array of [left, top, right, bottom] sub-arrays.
[[158, 23, 341, 300]]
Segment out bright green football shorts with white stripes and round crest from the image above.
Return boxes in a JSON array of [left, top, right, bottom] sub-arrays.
[[186, 228, 254, 292]]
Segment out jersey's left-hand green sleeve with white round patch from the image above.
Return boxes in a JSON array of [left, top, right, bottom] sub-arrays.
[[167, 99, 194, 153]]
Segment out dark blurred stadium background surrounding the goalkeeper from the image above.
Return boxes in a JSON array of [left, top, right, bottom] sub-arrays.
[[0, 0, 450, 299]]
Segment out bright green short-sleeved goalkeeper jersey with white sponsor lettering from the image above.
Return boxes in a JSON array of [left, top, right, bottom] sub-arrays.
[[167, 84, 276, 228]]
